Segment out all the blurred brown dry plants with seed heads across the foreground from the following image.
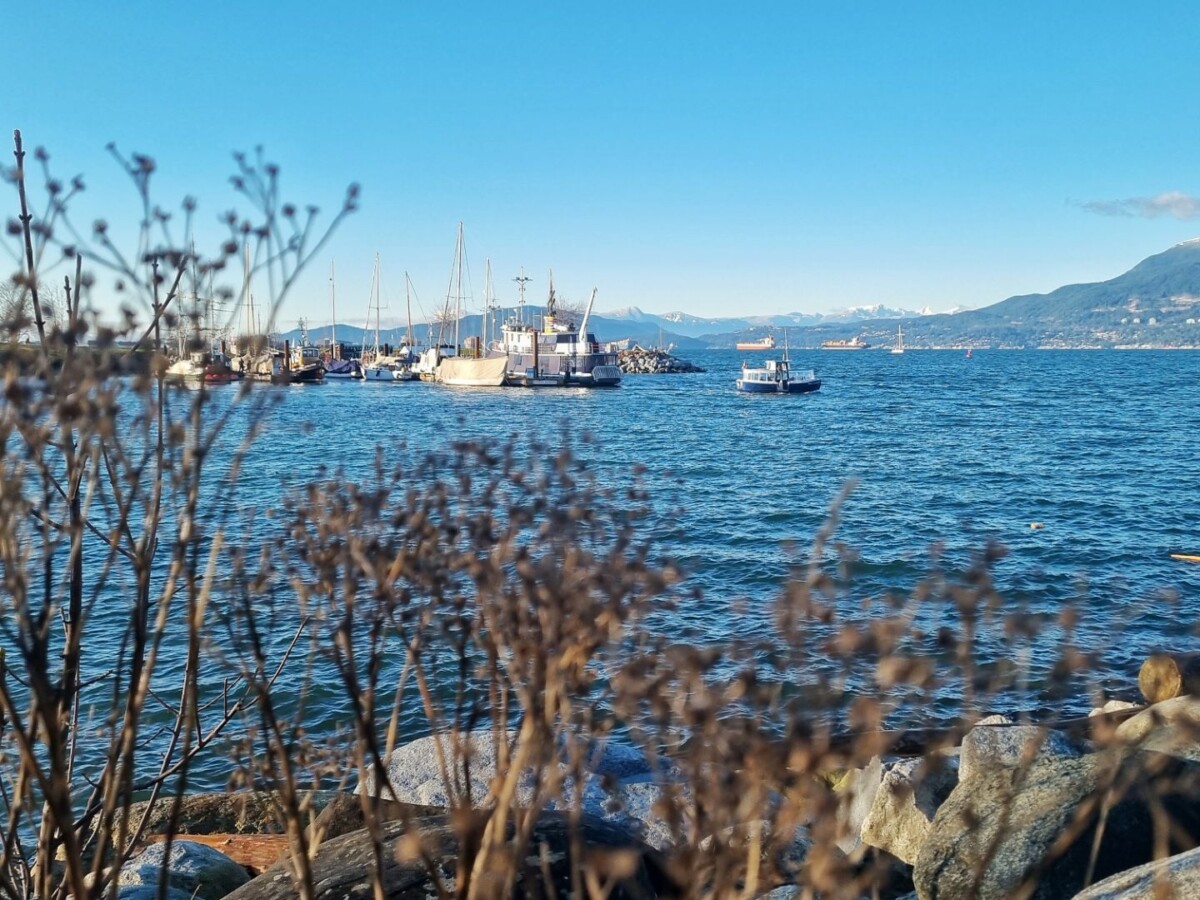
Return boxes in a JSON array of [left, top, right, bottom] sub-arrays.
[[0, 130, 1195, 900]]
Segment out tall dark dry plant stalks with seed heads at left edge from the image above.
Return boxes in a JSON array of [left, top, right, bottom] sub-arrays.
[[0, 132, 356, 898]]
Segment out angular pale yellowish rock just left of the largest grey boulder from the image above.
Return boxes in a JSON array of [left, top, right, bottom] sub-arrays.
[[860, 756, 959, 865]]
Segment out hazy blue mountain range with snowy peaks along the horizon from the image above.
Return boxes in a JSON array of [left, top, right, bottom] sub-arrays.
[[281, 239, 1200, 349]]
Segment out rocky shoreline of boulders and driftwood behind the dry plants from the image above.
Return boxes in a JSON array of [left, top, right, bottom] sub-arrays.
[[100, 681, 1200, 900]]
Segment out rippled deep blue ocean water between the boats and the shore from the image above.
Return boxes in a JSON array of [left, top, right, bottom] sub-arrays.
[[65, 350, 1200, 781]]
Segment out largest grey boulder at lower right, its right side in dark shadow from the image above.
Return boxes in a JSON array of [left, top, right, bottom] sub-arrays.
[[913, 752, 1200, 900]]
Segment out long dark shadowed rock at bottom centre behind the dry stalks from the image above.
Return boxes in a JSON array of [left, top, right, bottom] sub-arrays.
[[229, 812, 673, 900]]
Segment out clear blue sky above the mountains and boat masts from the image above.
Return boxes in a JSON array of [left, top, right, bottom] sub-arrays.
[[7, 0, 1200, 326]]
